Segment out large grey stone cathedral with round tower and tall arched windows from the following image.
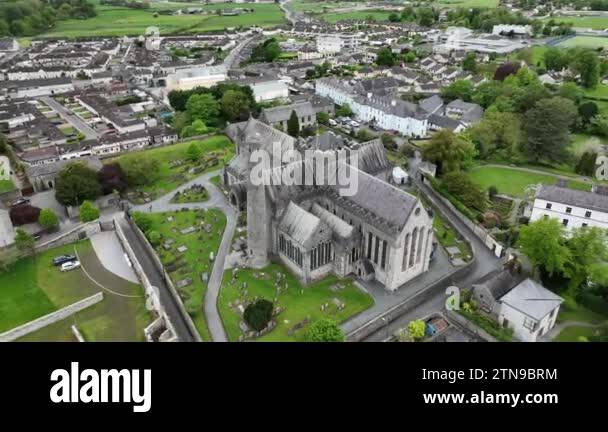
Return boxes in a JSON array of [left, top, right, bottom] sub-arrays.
[[223, 118, 434, 291]]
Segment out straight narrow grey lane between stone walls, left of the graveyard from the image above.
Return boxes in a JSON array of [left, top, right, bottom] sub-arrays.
[[116, 215, 196, 342]]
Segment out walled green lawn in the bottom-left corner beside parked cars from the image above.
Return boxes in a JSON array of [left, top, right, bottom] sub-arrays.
[[0, 240, 150, 341]]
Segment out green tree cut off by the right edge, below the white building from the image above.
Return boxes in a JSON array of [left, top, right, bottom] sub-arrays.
[[564, 227, 608, 290]]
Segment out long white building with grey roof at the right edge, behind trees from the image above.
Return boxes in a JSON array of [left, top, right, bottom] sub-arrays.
[[530, 185, 608, 233]]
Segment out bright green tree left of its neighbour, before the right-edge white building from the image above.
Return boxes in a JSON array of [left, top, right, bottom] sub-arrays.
[[518, 218, 570, 275]]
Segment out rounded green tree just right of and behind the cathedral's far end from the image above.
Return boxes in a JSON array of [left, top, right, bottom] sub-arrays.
[[423, 129, 475, 173]]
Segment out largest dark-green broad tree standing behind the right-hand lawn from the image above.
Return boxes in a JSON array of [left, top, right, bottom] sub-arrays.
[[523, 96, 577, 162]]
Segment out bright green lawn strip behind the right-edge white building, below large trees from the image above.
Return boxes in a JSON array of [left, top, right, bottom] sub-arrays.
[[469, 166, 591, 197]]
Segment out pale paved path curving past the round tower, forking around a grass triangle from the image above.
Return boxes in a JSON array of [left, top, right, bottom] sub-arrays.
[[132, 171, 237, 342]]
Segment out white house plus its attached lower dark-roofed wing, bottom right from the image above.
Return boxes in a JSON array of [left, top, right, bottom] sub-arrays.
[[472, 269, 563, 342]]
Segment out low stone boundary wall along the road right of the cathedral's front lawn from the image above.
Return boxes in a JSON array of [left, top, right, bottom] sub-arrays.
[[346, 257, 475, 342]]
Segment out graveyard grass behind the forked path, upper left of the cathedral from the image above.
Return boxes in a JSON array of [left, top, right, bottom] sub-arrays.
[[108, 135, 234, 202]]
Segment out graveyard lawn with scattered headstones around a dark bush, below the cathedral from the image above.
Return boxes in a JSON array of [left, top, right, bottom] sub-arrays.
[[218, 264, 374, 341]]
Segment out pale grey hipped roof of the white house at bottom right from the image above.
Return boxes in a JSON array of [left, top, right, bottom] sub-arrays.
[[500, 278, 564, 321]]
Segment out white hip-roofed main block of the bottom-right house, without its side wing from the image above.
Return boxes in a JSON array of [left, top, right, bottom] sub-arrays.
[[498, 278, 564, 342]]
